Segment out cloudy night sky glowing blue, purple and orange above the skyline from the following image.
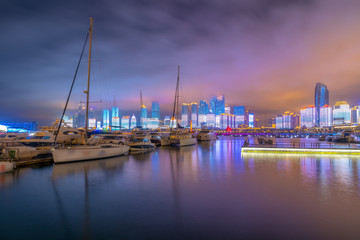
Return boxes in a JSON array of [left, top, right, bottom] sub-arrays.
[[0, 0, 360, 124]]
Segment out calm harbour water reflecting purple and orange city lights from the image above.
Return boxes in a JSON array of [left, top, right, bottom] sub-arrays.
[[0, 137, 360, 239]]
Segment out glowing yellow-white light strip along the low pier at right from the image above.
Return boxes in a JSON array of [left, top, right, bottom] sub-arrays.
[[241, 147, 360, 155]]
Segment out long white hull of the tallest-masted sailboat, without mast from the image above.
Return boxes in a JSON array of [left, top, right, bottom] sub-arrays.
[[52, 145, 129, 163]]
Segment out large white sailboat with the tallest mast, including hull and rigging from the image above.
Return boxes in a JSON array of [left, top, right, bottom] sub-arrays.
[[52, 18, 129, 163]]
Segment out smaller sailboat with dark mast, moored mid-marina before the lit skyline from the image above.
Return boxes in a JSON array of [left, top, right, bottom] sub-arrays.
[[169, 66, 197, 147]]
